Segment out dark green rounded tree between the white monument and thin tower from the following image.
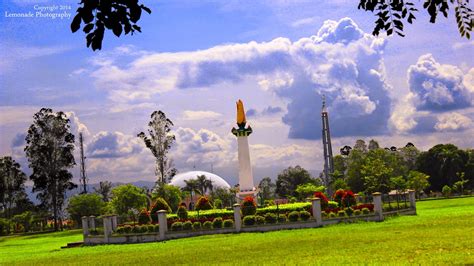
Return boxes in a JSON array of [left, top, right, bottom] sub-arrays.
[[276, 165, 320, 197]]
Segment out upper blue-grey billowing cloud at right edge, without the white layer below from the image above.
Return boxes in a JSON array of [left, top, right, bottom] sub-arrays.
[[408, 54, 474, 111]]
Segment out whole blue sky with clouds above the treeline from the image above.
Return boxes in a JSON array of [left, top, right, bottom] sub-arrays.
[[0, 0, 474, 187]]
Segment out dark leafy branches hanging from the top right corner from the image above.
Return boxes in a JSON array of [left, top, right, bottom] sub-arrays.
[[358, 0, 474, 39]]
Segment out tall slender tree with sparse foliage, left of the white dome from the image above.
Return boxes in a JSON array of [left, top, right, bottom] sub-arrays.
[[138, 111, 176, 185]]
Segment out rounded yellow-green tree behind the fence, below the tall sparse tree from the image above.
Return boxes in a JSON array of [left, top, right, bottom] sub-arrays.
[[110, 184, 147, 215]]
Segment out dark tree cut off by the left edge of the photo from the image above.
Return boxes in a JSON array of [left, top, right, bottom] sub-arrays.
[[0, 156, 26, 218]]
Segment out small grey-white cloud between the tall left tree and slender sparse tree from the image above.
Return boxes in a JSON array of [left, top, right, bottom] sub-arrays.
[[87, 131, 144, 158]]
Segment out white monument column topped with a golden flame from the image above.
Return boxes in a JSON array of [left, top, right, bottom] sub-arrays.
[[232, 100, 257, 199]]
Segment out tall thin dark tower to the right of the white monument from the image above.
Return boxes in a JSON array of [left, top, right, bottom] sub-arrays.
[[321, 95, 334, 195]]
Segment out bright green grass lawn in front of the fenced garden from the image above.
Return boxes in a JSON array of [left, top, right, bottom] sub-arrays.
[[0, 198, 474, 265]]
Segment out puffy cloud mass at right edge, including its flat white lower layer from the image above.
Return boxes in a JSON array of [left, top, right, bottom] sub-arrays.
[[390, 54, 474, 133]]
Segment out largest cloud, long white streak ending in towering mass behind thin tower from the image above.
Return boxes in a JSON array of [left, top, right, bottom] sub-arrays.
[[93, 18, 391, 139]]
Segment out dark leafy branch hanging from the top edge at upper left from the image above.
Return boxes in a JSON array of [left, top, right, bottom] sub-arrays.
[[71, 0, 151, 51]]
